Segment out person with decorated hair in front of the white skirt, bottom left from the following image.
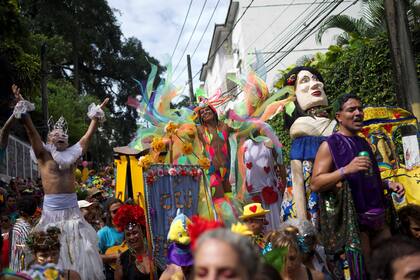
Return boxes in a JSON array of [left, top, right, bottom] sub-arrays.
[[25, 227, 81, 280]]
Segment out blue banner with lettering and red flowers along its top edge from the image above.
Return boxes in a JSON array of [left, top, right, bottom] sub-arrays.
[[144, 165, 202, 268]]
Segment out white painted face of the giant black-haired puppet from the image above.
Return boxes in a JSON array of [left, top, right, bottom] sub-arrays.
[[295, 70, 328, 111]]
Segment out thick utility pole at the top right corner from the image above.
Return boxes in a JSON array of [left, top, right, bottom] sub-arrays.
[[384, 0, 420, 120]]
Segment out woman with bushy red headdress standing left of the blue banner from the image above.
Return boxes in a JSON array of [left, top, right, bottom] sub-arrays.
[[113, 205, 154, 280]]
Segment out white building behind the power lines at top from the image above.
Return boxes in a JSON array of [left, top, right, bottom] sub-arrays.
[[200, 0, 360, 109]]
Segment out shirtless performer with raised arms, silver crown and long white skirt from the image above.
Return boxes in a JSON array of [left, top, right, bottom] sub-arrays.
[[13, 87, 108, 279]]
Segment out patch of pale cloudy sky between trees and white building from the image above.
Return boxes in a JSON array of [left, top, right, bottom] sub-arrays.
[[108, 0, 229, 92]]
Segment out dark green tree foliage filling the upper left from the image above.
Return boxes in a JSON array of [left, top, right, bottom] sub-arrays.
[[0, 0, 163, 166]]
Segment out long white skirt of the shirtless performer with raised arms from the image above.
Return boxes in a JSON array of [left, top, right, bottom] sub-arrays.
[[34, 193, 105, 280]]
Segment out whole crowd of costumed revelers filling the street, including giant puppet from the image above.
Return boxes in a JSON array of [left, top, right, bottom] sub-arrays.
[[0, 67, 420, 280]]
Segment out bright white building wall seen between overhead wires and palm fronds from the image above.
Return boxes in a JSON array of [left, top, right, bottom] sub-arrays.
[[200, 0, 360, 111]]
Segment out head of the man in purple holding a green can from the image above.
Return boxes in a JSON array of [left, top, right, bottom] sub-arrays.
[[335, 98, 364, 135]]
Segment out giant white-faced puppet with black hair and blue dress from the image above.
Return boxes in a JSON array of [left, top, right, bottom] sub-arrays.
[[282, 66, 336, 226]]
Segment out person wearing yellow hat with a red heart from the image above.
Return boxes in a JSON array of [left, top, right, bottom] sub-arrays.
[[239, 203, 270, 249]]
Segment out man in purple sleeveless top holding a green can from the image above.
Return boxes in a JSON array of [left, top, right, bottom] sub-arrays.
[[311, 94, 404, 259]]
